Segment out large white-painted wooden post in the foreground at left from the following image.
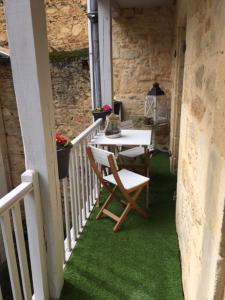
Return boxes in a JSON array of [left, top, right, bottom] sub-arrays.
[[4, 0, 64, 299]]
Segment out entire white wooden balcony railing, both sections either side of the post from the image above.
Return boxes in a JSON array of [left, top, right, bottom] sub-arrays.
[[0, 119, 102, 300]]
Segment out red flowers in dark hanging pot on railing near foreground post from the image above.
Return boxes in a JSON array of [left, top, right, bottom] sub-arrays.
[[55, 131, 72, 179]]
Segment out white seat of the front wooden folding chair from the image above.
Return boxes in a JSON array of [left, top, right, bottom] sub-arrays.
[[103, 169, 149, 190]]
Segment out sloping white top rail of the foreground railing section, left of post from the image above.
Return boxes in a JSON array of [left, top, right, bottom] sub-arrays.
[[0, 182, 33, 216]]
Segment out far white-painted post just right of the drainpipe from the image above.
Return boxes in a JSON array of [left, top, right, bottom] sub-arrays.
[[98, 0, 113, 107]]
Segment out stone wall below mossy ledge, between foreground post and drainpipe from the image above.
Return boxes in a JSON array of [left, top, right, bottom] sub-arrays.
[[51, 58, 92, 139]]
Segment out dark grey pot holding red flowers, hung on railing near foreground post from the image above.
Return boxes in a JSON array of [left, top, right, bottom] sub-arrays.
[[57, 145, 72, 179]]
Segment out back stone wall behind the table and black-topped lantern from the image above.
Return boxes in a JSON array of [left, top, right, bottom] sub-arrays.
[[113, 6, 174, 119]]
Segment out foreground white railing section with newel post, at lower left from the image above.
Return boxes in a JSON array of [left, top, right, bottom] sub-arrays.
[[0, 170, 49, 300]]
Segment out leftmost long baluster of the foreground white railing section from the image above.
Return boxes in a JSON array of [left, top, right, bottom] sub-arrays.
[[0, 211, 22, 300]]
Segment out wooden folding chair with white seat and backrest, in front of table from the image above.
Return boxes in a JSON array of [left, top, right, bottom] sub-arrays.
[[87, 146, 149, 232]]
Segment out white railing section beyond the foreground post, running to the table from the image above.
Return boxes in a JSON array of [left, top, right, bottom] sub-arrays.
[[59, 119, 102, 261]]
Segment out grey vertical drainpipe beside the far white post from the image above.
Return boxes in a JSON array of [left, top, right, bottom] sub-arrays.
[[87, 0, 102, 109]]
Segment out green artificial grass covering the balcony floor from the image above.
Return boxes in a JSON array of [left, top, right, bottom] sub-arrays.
[[61, 153, 183, 300]]
